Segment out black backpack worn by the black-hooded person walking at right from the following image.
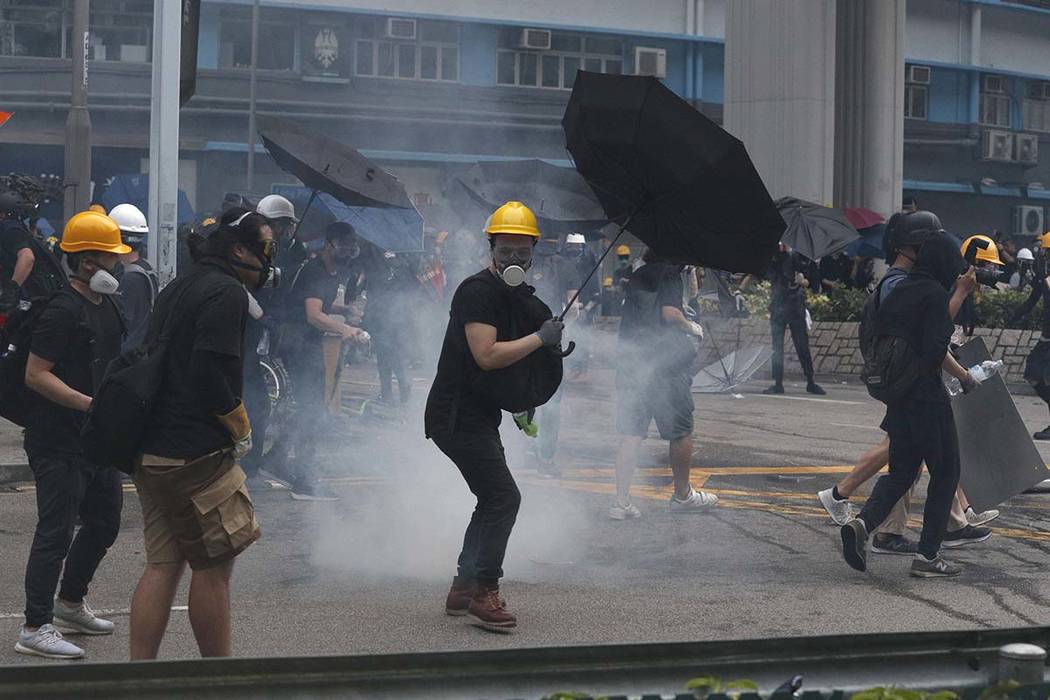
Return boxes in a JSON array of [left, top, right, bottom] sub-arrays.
[[858, 282, 919, 404]]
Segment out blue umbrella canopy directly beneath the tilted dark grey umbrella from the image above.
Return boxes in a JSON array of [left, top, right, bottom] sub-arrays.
[[273, 185, 423, 253]]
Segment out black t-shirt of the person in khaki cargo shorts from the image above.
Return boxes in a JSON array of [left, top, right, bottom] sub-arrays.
[[143, 260, 248, 460]]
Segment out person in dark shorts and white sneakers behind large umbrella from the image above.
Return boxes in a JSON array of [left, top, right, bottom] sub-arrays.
[[609, 251, 718, 521]]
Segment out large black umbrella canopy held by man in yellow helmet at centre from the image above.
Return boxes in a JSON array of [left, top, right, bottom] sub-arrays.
[[562, 71, 784, 272]]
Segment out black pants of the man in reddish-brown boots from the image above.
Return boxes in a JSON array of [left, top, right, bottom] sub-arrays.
[[434, 431, 522, 584]]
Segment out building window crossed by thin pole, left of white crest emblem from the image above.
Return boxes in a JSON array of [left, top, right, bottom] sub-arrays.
[[218, 7, 299, 70]]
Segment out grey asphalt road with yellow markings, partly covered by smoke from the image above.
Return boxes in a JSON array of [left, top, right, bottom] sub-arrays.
[[0, 370, 1050, 663]]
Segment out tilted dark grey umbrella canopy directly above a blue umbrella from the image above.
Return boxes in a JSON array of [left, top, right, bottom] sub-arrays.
[[258, 116, 412, 209]]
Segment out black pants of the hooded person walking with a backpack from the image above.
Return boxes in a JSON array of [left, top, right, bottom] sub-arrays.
[[860, 401, 959, 558]]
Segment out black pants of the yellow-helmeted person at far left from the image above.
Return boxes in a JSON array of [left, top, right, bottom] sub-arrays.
[[25, 453, 124, 628]]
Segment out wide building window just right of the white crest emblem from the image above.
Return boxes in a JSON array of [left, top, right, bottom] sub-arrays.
[[354, 17, 459, 82]]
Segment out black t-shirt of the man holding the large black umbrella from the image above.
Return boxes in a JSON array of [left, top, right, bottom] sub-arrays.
[[424, 270, 512, 438]]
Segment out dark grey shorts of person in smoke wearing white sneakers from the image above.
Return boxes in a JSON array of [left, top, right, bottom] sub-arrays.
[[616, 372, 695, 440]]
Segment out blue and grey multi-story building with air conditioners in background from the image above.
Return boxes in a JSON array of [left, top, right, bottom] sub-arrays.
[[0, 0, 1050, 238]]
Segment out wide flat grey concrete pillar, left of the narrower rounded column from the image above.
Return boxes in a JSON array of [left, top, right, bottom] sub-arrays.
[[723, 0, 837, 204]]
